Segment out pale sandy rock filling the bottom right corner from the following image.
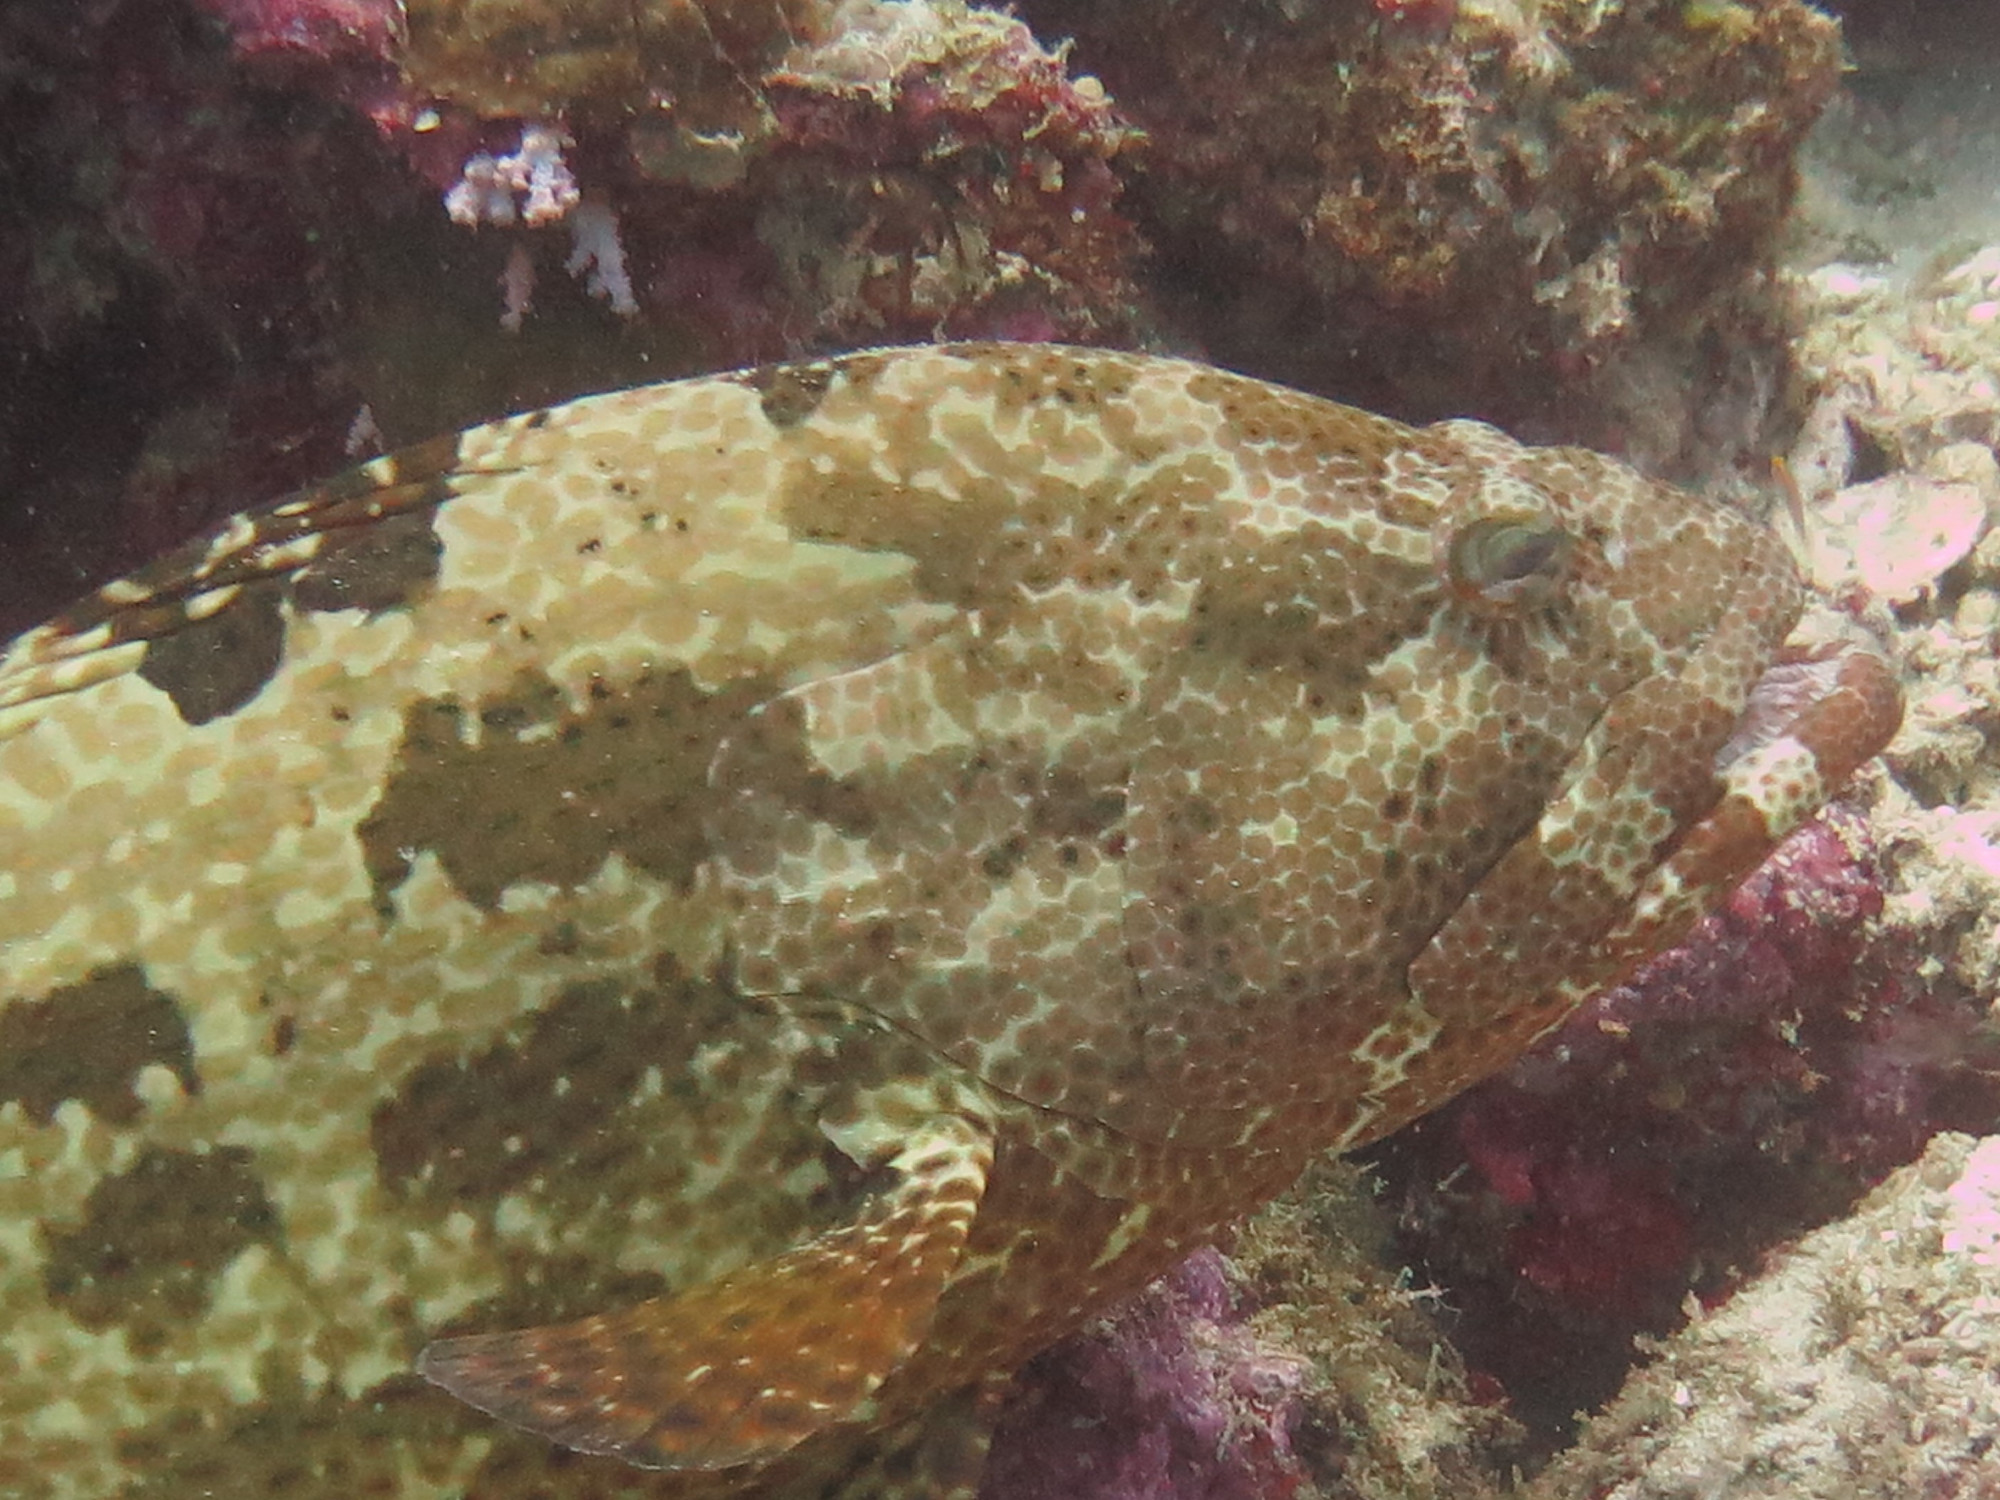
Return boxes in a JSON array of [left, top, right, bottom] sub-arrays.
[[1524, 1134, 2000, 1500]]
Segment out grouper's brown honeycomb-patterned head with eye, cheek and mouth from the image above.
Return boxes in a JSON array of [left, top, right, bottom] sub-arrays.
[[1122, 392, 1900, 1144]]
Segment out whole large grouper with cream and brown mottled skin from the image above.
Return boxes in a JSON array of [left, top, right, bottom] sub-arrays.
[[0, 346, 1896, 1500]]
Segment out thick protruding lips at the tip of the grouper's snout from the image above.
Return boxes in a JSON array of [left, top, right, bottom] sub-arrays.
[[1714, 640, 1902, 788]]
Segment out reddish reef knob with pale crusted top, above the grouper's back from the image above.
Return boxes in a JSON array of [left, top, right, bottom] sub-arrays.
[[644, 0, 1140, 356]]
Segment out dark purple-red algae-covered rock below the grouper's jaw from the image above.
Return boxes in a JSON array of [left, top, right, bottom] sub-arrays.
[[1380, 810, 2000, 1432]]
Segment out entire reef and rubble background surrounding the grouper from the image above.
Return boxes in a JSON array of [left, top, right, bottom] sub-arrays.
[[0, 0, 2000, 1500]]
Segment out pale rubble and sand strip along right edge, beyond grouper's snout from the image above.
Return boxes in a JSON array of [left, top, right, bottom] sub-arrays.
[[1788, 17, 2000, 1096]]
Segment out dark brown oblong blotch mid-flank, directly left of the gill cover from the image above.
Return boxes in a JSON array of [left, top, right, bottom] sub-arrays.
[[360, 670, 768, 908]]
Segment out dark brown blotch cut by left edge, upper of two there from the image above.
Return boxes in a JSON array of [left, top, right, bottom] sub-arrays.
[[0, 964, 200, 1124]]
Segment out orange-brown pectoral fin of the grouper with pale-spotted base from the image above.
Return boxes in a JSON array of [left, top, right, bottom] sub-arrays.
[[418, 1116, 992, 1470]]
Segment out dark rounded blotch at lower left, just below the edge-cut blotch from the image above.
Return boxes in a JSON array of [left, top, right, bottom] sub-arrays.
[[44, 1146, 278, 1354]]
